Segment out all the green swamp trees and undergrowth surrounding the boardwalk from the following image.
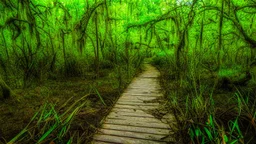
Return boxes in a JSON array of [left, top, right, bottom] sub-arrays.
[[0, 0, 256, 144]]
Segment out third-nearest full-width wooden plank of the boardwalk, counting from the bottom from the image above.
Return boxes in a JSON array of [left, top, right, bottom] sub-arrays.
[[102, 124, 170, 135]]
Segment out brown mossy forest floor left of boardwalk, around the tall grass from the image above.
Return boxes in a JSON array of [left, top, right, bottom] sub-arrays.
[[0, 69, 144, 143]]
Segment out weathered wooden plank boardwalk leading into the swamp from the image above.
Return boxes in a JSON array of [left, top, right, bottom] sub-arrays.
[[92, 64, 171, 144]]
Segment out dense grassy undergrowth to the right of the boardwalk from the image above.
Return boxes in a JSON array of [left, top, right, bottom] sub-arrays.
[[152, 50, 256, 144]]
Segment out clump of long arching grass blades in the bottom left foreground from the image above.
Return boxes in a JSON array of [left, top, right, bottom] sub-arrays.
[[8, 94, 90, 144]]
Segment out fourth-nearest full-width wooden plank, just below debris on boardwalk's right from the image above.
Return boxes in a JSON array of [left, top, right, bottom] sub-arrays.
[[104, 118, 170, 129]]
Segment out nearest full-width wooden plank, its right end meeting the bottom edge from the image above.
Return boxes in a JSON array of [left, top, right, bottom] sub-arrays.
[[94, 134, 166, 144]]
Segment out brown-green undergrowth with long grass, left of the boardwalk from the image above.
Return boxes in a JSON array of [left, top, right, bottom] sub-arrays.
[[0, 58, 144, 143]]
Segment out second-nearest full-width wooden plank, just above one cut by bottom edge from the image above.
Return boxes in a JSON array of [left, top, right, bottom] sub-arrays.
[[96, 129, 166, 141]]
